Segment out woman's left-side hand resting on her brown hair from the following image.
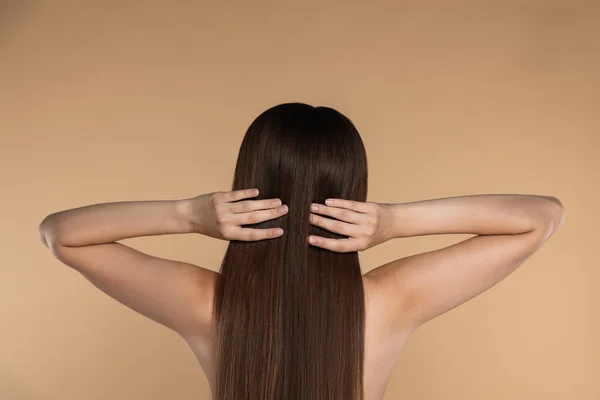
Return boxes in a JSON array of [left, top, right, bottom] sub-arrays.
[[180, 189, 288, 241]]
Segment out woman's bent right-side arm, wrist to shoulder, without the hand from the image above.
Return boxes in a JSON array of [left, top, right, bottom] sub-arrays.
[[365, 194, 565, 333]]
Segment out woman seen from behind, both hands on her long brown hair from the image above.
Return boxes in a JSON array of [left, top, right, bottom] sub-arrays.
[[39, 103, 565, 400]]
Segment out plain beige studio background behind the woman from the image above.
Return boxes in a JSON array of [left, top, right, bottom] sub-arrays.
[[0, 0, 600, 400]]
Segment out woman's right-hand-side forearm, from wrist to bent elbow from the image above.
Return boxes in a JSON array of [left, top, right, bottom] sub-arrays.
[[392, 194, 564, 237]]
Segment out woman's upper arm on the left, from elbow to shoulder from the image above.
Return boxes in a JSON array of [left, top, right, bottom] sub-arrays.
[[44, 242, 218, 337]]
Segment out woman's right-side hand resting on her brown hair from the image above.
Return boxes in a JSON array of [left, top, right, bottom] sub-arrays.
[[309, 199, 394, 253]]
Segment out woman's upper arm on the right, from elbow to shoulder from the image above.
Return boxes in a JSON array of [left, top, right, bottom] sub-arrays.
[[365, 217, 558, 332]]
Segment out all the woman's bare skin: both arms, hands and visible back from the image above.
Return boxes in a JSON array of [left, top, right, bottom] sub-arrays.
[[39, 189, 565, 400]]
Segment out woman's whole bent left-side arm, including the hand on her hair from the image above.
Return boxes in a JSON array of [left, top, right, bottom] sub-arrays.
[[39, 189, 287, 337]]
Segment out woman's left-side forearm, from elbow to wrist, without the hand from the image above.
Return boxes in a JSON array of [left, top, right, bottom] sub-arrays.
[[39, 200, 191, 246]]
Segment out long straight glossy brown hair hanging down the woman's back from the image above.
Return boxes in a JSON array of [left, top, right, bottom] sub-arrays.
[[213, 103, 367, 400]]
